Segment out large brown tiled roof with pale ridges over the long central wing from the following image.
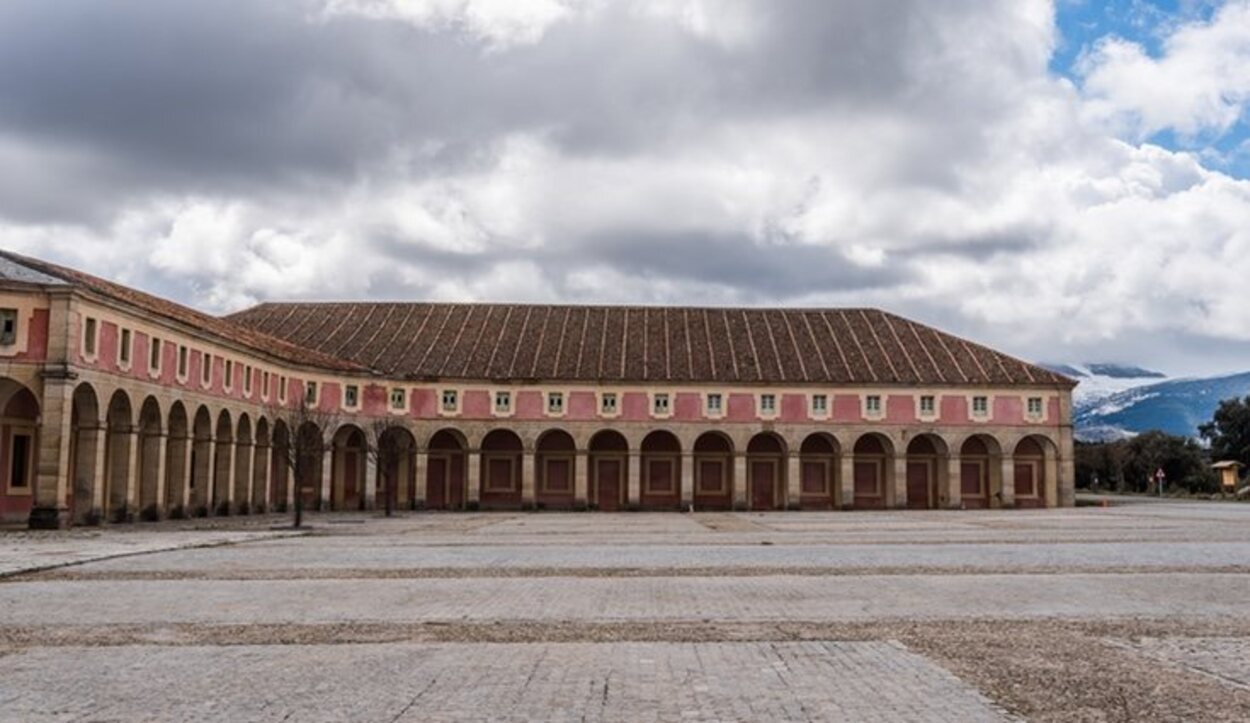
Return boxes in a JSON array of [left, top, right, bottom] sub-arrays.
[[229, 303, 1075, 388]]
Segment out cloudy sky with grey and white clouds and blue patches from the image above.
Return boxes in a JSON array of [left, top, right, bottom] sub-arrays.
[[0, 0, 1250, 374]]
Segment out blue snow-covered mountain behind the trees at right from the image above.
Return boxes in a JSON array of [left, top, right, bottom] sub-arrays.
[[1046, 364, 1250, 442]]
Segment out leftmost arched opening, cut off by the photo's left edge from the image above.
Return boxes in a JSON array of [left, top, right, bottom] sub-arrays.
[[0, 378, 40, 522]]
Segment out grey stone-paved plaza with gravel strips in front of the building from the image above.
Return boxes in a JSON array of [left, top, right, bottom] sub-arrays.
[[0, 502, 1250, 720]]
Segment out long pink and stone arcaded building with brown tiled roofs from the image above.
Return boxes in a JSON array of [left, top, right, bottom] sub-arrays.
[[0, 251, 1075, 527]]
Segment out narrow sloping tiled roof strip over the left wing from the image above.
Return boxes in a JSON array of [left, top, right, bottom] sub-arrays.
[[0, 250, 368, 372]]
